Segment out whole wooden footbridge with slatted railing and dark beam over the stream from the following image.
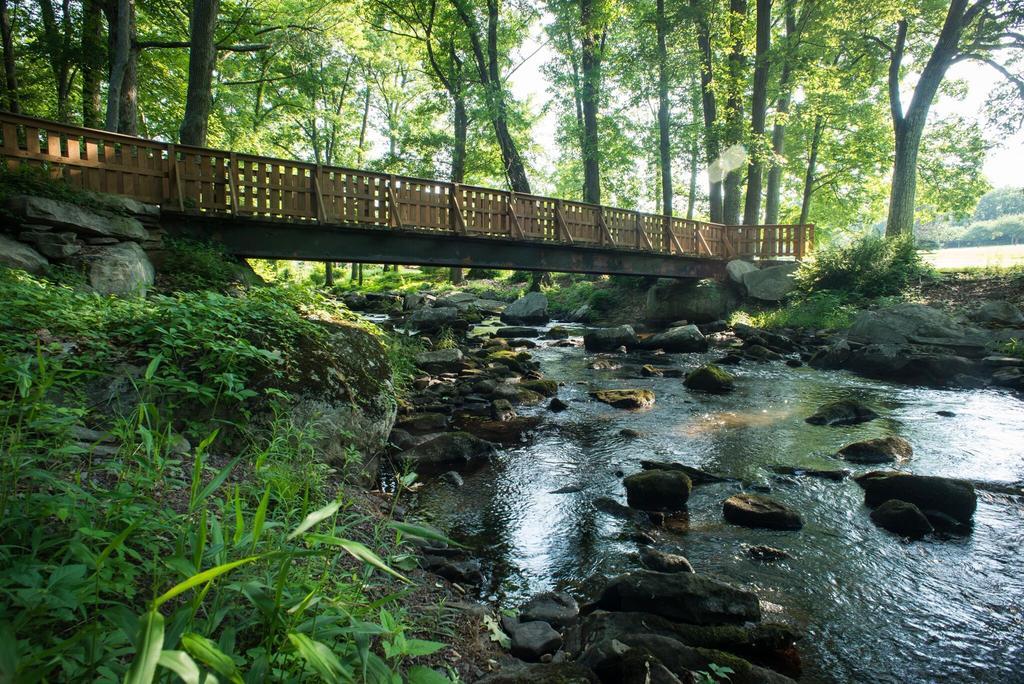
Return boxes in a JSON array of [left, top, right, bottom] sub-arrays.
[[0, 113, 814, 277]]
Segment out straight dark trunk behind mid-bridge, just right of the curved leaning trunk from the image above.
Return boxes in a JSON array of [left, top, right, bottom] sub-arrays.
[[580, 0, 601, 204]]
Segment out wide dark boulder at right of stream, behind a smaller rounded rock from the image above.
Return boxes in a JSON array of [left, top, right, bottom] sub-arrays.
[[854, 470, 978, 523]]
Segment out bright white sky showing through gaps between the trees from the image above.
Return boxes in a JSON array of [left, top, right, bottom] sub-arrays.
[[509, 27, 1024, 187]]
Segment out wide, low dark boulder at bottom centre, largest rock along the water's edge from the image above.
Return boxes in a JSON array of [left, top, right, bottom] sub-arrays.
[[596, 570, 761, 625]]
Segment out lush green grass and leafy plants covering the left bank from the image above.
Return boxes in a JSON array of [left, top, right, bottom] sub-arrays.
[[0, 270, 452, 683]]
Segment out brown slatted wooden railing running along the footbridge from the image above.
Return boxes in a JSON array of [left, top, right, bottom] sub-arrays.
[[0, 113, 814, 259]]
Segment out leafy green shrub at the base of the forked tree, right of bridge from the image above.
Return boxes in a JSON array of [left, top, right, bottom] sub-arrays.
[[796, 236, 934, 298]]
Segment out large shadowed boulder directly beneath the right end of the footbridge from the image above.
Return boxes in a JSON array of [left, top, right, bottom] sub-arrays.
[[644, 280, 739, 325]]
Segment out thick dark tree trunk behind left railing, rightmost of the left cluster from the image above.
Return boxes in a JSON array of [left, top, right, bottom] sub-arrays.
[[178, 0, 220, 147]]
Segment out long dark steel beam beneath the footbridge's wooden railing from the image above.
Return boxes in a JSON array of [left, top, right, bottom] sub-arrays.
[[161, 211, 725, 277]]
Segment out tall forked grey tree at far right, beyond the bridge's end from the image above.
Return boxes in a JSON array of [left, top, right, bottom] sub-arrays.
[[886, 0, 1024, 236]]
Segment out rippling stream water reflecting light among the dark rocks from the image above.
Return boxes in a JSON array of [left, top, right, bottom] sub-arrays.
[[411, 325, 1024, 683]]
